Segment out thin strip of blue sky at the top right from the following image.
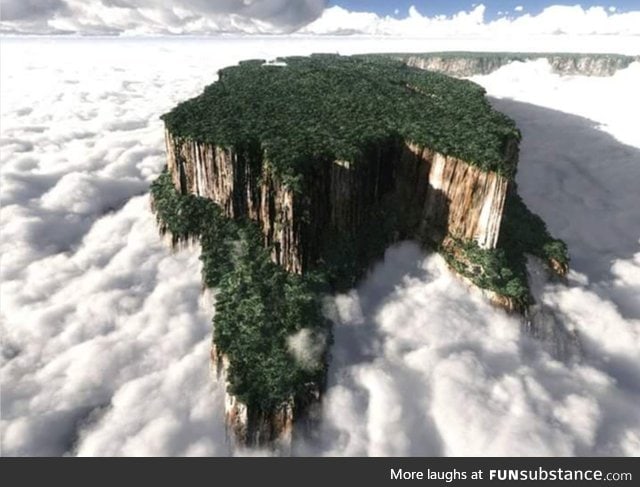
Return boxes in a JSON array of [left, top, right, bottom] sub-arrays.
[[330, 0, 640, 19]]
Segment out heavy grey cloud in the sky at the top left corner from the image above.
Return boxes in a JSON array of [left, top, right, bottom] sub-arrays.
[[2, 0, 327, 34]]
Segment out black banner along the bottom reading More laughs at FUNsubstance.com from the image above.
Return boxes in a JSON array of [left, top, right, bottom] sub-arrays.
[[0, 458, 640, 487]]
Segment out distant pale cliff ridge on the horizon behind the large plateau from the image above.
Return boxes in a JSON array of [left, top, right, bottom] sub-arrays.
[[393, 52, 640, 78]]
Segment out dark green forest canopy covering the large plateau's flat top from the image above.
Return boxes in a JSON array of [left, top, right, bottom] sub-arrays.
[[163, 55, 520, 177]]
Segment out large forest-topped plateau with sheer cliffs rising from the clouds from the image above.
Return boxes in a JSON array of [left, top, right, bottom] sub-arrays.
[[152, 55, 568, 453]]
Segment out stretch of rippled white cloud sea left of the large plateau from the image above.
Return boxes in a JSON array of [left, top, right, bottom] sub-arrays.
[[0, 41, 236, 455]]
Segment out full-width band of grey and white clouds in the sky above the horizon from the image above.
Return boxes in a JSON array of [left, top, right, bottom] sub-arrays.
[[1, 0, 640, 38]]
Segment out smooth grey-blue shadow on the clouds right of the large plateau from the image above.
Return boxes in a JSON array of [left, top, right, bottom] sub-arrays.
[[491, 98, 640, 318]]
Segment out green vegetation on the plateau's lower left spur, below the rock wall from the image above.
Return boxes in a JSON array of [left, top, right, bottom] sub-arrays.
[[151, 171, 329, 411]]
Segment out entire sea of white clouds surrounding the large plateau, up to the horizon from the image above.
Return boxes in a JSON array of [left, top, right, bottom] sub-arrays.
[[0, 38, 640, 456]]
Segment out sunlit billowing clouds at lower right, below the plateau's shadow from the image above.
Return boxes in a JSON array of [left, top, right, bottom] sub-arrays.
[[305, 248, 640, 456]]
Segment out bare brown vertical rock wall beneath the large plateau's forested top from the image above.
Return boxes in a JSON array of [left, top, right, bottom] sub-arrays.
[[165, 131, 517, 273]]
